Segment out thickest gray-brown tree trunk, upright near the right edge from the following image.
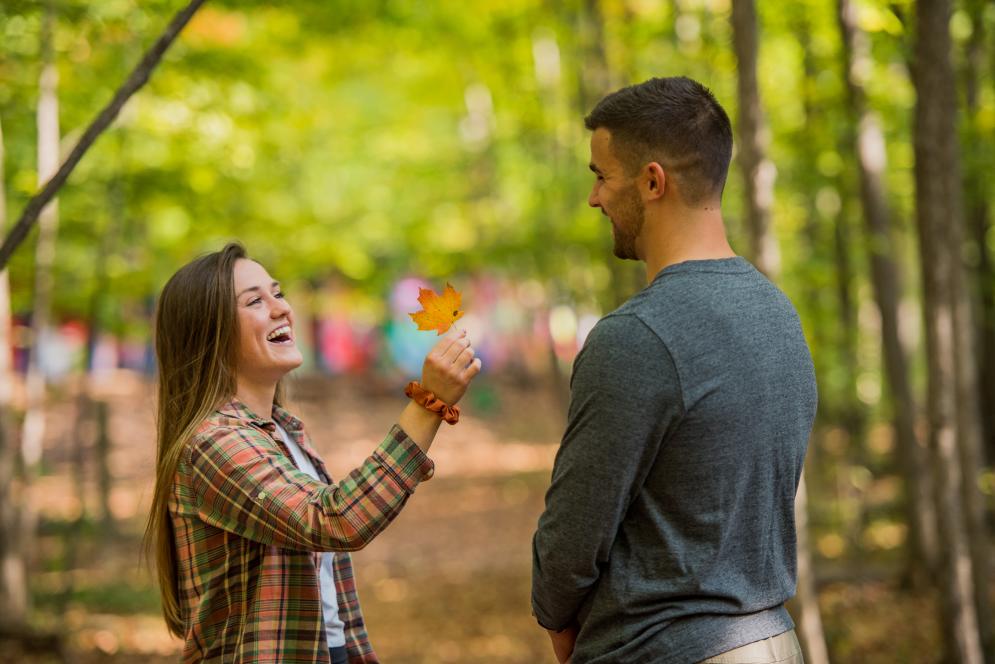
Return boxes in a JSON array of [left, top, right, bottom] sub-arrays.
[[914, 0, 987, 664]]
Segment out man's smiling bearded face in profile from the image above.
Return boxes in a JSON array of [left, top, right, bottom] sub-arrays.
[[587, 127, 646, 260]]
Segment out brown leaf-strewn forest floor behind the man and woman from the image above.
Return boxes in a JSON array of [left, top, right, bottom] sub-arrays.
[[0, 373, 952, 664]]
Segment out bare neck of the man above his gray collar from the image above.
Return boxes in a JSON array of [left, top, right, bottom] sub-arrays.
[[643, 207, 736, 283]]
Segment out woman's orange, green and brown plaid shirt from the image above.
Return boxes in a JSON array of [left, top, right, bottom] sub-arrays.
[[169, 401, 434, 664]]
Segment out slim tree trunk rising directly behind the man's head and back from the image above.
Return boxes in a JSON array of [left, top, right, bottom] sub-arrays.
[[732, 0, 829, 664]]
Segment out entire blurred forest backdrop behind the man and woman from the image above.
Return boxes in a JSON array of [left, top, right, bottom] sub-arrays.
[[0, 0, 995, 664]]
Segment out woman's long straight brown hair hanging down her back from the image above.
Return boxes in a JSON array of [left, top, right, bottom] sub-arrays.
[[145, 242, 249, 637]]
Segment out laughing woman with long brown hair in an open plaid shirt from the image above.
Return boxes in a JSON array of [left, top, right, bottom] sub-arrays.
[[146, 243, 480, 664]]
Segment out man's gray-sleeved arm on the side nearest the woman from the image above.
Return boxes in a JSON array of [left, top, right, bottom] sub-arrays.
[[532, 314, 684, 631]]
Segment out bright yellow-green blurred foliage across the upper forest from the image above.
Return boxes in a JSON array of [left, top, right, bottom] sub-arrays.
[[0, 0, 995, 392]]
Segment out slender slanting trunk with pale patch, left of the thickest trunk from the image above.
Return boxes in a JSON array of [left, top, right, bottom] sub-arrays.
[[837, 0, 939, 586]]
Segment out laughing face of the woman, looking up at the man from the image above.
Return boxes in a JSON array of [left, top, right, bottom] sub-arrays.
[[233, 258, 304, 384]]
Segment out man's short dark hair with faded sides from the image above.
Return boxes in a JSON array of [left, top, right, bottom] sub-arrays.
[[584, 76, 732, 205]]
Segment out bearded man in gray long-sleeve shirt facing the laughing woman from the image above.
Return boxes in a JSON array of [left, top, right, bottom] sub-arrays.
[[532, 78, 816, 664]]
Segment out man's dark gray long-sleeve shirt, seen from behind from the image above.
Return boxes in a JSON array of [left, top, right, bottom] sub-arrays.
[[532, 257, 817, 664]]
